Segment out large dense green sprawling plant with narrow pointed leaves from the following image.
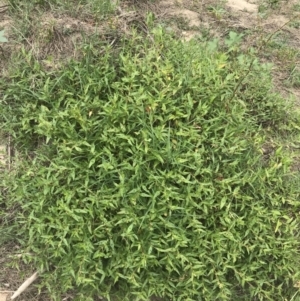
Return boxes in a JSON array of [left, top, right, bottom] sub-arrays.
[[1, 28, 300, 301]]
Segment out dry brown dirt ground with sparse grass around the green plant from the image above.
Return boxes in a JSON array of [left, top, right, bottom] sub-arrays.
[[0, 0, 300, 301]]
